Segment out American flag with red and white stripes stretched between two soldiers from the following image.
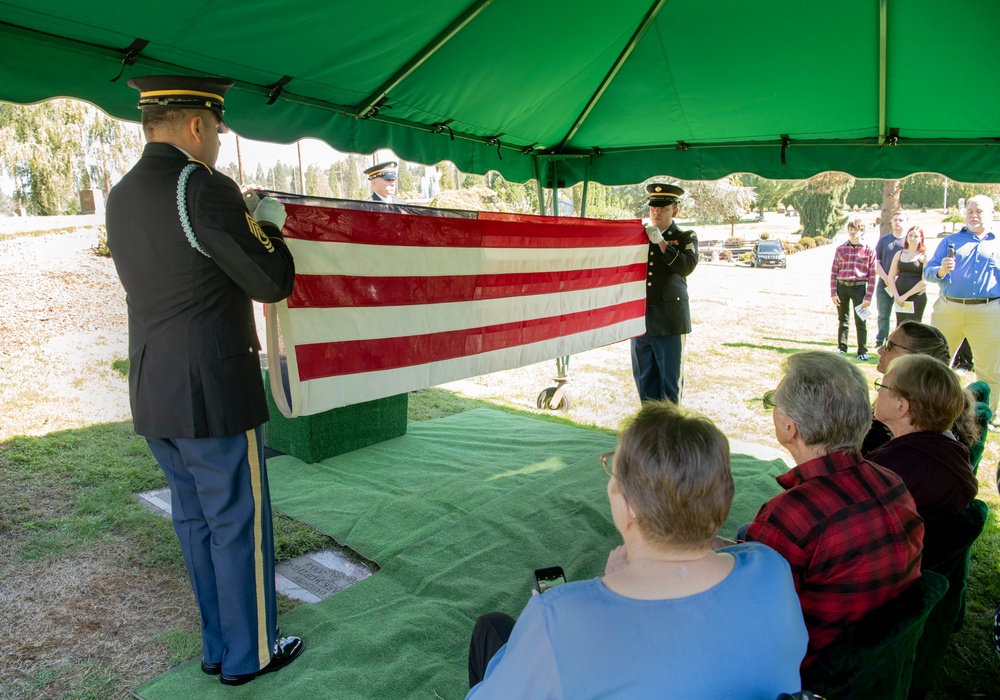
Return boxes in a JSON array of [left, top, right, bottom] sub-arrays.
[[267, 196, 648, 417]]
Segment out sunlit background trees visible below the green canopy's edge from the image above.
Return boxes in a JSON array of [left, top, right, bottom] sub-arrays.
[[0, 100, 1000, 238]]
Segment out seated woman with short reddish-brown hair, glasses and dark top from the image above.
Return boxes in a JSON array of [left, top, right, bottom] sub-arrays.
[[867, 355, 979, 537]]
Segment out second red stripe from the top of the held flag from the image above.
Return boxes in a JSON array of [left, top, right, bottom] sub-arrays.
[[288, 263, 646, 309]]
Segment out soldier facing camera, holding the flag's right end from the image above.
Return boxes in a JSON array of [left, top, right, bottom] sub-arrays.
[[632, 182, 698, 404]]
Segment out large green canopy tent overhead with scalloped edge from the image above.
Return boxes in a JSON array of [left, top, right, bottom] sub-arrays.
[[0, 0, 1000, 186]]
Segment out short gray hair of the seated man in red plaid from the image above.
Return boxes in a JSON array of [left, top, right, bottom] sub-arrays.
[[774, 350, 872, 454]]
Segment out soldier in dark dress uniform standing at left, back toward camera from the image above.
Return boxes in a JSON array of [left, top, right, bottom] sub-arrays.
[[107, 76, 303, 685]]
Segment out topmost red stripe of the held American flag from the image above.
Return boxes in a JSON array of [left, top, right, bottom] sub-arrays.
[[282, 204, 647, 248]]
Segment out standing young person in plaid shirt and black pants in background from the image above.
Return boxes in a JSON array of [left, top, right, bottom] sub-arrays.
[[830, 219, 876, 362]]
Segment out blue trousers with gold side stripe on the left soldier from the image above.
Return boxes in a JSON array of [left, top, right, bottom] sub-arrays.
[[146, 427, 277, 675]]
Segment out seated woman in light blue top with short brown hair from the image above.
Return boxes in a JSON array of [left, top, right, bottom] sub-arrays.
[[468, 402, 807, 700]]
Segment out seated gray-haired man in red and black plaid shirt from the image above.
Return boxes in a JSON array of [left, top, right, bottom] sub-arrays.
[[745, 351, 924, 668]]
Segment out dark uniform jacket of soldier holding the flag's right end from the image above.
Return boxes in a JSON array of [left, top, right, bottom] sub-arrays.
[[646, 223, 698, 336]]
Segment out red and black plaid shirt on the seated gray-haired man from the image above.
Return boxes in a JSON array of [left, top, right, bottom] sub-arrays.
[[746, 452, 924, 668]]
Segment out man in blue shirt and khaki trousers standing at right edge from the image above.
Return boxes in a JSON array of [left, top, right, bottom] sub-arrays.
[[924, 194, 1000, 421]]
